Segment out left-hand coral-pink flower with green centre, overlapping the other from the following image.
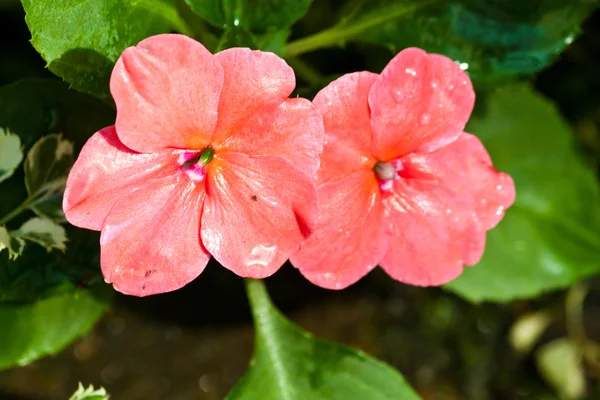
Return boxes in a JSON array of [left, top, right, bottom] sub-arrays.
[[63, 35, 323, 296]]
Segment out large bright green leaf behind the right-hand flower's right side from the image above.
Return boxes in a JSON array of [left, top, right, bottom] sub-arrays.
[[446, 85, 600, 301]]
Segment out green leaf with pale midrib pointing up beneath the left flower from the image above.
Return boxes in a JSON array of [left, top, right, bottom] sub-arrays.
[[227, 280, 419, 400]]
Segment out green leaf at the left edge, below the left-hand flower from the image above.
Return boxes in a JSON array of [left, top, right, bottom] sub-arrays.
[[0, 287, 110, 370]]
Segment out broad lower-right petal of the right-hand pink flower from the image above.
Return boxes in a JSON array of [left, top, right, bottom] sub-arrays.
[[379, 178, 485, 286]]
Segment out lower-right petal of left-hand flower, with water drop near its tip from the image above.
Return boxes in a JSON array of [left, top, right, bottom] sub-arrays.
[[202, 152, 319, 279]]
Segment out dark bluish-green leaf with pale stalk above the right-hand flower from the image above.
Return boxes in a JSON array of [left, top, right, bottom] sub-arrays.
[[286, 0, 598, 83]]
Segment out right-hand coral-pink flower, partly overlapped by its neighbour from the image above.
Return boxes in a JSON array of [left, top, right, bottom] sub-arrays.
[[291, 49, 515, 289]]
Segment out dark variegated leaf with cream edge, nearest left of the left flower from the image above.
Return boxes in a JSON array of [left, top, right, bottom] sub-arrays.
[[25, 134, 75, 221]]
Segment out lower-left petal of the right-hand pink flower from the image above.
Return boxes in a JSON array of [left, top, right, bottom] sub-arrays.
[[290, 171, 388, 289]]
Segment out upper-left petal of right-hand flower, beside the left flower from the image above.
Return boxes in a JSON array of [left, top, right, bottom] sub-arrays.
[[313, 72, 377, 184]]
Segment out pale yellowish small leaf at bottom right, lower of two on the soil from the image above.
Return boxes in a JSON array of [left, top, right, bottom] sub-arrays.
[[536, 338, 586, 399]]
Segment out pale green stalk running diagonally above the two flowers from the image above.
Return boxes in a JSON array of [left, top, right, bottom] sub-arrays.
[[283, 0, 438, 58]]
